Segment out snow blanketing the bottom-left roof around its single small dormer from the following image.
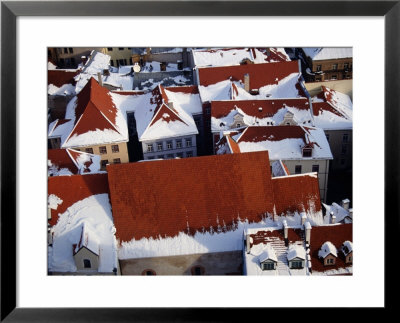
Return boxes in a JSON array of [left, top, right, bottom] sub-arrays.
[[48, 195, 118, 273]]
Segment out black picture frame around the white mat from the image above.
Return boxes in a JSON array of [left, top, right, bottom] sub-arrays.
[[0, 0, 400, 322]]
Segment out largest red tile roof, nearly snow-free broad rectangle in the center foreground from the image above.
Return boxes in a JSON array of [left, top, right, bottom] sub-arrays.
[[107, 152, 273, 241]]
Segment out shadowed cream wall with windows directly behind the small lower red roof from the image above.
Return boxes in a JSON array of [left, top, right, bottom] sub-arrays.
[[276, 159, 329, 201]]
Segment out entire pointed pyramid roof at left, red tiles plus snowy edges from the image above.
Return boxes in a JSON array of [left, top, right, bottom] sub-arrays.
[[61, 78, 128, 148]]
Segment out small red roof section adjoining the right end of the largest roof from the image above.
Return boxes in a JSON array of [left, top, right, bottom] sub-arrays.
[[272, 174, 321, 215]]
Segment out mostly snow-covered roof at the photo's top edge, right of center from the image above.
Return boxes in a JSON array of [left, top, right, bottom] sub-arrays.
[[192, 48, 290, 67]]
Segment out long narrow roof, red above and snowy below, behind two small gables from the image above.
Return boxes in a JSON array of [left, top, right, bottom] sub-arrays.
[[211, 98, 312, 132]]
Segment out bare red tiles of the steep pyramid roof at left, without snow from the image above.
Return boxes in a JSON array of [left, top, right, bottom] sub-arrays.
[[67, 77, 118, 141]]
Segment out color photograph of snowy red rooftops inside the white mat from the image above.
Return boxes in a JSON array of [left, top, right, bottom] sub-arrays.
[[47, 47, 353, 276]]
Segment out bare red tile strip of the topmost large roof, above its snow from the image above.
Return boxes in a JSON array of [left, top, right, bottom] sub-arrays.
[[198, 61, 300, 89]]
